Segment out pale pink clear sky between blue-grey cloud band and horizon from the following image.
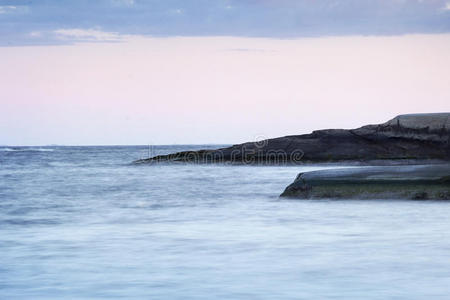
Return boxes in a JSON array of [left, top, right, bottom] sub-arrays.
[[0, 34, 450, 145]]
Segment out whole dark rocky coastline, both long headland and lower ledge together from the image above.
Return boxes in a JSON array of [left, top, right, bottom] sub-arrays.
[[135, 113, 450, 200]]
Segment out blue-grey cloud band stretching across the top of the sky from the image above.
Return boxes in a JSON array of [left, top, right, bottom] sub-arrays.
[[0, 0, 450, 45]]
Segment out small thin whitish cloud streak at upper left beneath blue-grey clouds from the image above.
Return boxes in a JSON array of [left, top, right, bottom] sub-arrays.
[[53, 28, 123, 42]]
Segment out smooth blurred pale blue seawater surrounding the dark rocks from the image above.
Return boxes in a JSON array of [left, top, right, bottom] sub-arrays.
[[0, 146, 450, 299]]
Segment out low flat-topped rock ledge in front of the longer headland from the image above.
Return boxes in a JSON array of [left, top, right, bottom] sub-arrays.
[[280, 164, 450, 200]]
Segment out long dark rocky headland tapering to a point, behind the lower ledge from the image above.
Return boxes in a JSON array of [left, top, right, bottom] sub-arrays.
[[136, 113, 450, 164]]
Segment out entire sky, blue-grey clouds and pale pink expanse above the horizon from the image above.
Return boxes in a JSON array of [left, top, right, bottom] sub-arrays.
[[0, 0, 450, 145]]
